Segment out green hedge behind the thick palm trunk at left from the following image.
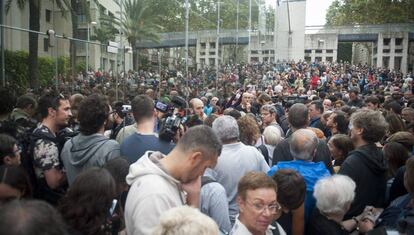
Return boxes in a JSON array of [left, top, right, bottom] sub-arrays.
[[5, 50, 70, 91]]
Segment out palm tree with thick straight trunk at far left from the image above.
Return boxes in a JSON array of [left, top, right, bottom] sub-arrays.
[[6, 0, 70, 88]]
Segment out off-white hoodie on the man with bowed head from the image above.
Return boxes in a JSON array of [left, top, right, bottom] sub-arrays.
[[125, 151, 186, 235]]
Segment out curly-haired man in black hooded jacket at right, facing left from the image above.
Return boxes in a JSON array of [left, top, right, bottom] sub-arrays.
[[338, 110, 388, 219]]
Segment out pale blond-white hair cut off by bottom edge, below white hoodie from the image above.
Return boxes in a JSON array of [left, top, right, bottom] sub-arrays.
[[152, 206, 219, 235]]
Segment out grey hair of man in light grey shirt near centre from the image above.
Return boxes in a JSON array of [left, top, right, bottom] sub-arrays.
[[213, 115, 240, 142]]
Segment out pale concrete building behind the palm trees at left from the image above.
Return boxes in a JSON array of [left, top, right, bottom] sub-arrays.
[[4, 0, 132, 71]]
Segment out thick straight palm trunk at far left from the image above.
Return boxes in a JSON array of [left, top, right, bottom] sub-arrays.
[[28, 0, 40, 89]]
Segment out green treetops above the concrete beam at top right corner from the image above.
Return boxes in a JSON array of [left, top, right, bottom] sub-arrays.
[[326, 0, 414, 25]]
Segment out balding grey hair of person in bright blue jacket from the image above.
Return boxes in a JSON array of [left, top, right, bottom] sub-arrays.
[[289, 129, 318, 161]]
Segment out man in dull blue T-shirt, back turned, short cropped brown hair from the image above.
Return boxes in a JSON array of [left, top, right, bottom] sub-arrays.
[[119, 95, 174, 164]]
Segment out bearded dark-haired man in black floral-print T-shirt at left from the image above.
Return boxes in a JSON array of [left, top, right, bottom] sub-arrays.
[[31, 94, 72, 205]]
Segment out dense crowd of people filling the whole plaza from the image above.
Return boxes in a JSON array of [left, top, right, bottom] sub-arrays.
[[0, 61, 414, 235]]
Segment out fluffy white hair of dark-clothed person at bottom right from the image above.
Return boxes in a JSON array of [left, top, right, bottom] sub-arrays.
[[313, 175, 356, 214]]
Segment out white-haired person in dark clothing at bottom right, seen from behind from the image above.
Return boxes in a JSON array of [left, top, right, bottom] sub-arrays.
[[306, 175, 358, 235]]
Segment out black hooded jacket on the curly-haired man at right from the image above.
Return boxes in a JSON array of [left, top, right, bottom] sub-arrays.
[[338, 144, 387, 219]]
